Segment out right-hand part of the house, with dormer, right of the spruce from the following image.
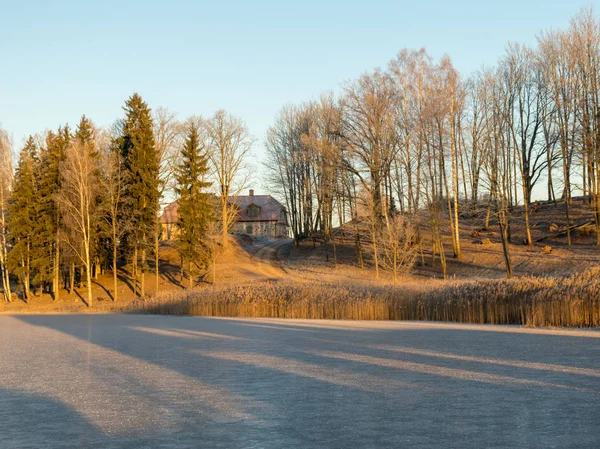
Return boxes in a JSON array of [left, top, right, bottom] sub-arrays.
[[230, 189, 290, 238]]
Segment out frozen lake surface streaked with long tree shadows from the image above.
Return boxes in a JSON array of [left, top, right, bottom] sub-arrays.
[[0, 315, 600, 449]]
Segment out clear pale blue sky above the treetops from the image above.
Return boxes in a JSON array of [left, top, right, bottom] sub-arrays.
[[0, 0, 592, 189]]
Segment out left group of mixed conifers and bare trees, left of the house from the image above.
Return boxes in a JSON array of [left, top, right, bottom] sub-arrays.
[[0, 94, 252, 307]]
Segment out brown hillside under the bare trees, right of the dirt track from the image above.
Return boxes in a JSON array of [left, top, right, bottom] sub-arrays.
[[287, 198, 600, 280]]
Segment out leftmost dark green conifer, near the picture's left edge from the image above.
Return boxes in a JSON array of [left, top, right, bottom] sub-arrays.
[[7, 136, 39, 301]]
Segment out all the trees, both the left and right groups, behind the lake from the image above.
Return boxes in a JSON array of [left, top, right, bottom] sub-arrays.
[[0, 9, 600, 300]]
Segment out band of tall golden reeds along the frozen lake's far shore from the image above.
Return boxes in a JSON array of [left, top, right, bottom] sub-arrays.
[[125, 268, 600, 327]]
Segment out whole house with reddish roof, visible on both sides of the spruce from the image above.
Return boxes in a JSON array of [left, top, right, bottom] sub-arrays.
[[160, 189, 290, 240]]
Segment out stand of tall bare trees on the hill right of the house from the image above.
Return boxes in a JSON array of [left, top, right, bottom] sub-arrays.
[[266, 9, 600, 277]]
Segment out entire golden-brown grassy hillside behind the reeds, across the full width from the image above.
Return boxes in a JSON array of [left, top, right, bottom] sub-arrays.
[[3, 194, 600, 313]]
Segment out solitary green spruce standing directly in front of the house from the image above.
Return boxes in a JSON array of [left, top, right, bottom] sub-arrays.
[[176, 122, 211, 288]]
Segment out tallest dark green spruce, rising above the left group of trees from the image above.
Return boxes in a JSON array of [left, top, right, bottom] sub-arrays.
[[120, 93, 159, 297]]
